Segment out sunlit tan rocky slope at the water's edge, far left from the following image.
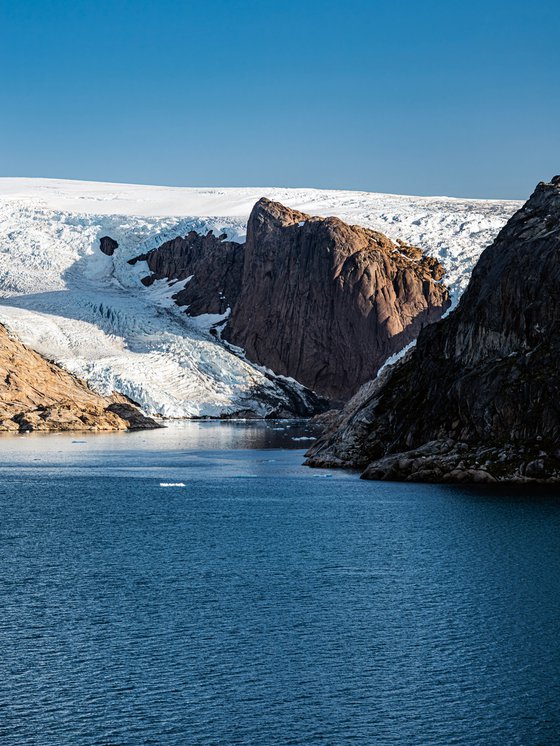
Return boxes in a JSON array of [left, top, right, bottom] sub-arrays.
[[0, 325, 160, 432]]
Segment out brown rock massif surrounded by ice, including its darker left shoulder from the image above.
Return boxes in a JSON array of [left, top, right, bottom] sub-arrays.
[[131, 199, 449, 400]]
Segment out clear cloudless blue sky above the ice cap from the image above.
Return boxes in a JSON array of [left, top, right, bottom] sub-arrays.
[[0, 0, 560, 198]]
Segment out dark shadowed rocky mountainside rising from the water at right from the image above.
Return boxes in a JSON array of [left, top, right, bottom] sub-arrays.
[[308, 177, 560, 482]]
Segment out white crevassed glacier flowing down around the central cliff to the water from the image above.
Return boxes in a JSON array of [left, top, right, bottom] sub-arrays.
[[0, 178, 521, 418]]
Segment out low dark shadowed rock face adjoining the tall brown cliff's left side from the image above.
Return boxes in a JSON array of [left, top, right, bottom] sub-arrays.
[[129, 231, 243, 316]]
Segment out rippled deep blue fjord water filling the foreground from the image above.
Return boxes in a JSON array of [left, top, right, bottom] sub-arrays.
[[0, 423, 560, 746]]
